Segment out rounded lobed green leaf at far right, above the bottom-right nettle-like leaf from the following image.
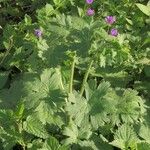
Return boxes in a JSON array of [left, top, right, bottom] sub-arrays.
[[116, 89, 146, 123]]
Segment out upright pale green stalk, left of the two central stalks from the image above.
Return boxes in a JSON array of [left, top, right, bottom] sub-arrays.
[[69, 56, 75, 93]]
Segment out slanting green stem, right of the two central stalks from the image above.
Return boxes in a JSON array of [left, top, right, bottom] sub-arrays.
[[80, 60, 93, 96]]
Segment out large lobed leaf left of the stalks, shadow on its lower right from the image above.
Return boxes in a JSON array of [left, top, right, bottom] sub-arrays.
[[22, 68, 66, 109]]
